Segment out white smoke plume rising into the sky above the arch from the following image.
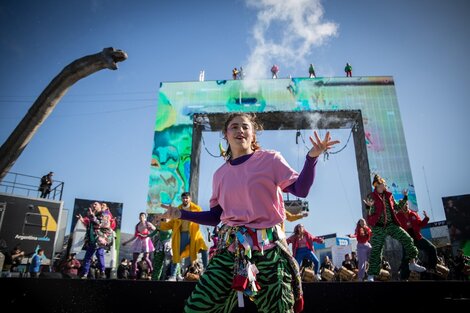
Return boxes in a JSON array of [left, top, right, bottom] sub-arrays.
[[244, 0, 338, 81]]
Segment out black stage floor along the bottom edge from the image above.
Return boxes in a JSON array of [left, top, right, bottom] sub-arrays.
[[0, 278, 470, 313]]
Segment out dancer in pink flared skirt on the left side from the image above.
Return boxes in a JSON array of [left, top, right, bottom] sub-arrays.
[[122, 212, 155, 279]]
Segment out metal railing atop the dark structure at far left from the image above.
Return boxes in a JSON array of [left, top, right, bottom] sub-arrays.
[[0, 172, 64, 201]]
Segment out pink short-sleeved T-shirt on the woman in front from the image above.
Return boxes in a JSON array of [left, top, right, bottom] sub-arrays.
[[210, 150, 299, 228]]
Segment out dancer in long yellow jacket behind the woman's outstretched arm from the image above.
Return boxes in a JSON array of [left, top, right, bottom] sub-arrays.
[[160, 192, 208, 281]]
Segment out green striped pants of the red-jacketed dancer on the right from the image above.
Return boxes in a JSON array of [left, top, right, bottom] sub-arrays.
[[368, 223, 418, 275]]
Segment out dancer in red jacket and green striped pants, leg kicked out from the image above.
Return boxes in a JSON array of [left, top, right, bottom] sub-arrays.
[[364, 174, 426, 281]]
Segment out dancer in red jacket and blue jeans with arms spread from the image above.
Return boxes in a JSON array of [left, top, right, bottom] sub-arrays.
[[287, 224, 325, 280]]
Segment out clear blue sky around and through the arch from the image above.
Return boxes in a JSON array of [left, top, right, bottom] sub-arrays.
[[0, 0, 470, 234]]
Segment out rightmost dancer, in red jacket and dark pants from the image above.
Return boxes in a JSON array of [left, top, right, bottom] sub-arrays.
[[397, 202, 437, 280]]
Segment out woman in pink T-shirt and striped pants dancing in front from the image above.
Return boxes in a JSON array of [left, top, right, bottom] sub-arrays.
[[165, 113, 338, 312]]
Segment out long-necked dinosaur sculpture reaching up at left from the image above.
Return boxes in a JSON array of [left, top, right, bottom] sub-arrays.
[[0, 48, 127, 181]]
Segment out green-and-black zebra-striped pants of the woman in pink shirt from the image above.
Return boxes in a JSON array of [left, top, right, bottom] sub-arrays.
[[184, 247, 294, 313]]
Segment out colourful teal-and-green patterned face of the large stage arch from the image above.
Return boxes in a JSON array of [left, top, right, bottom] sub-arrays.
[[147, 76, 417, 213]]
